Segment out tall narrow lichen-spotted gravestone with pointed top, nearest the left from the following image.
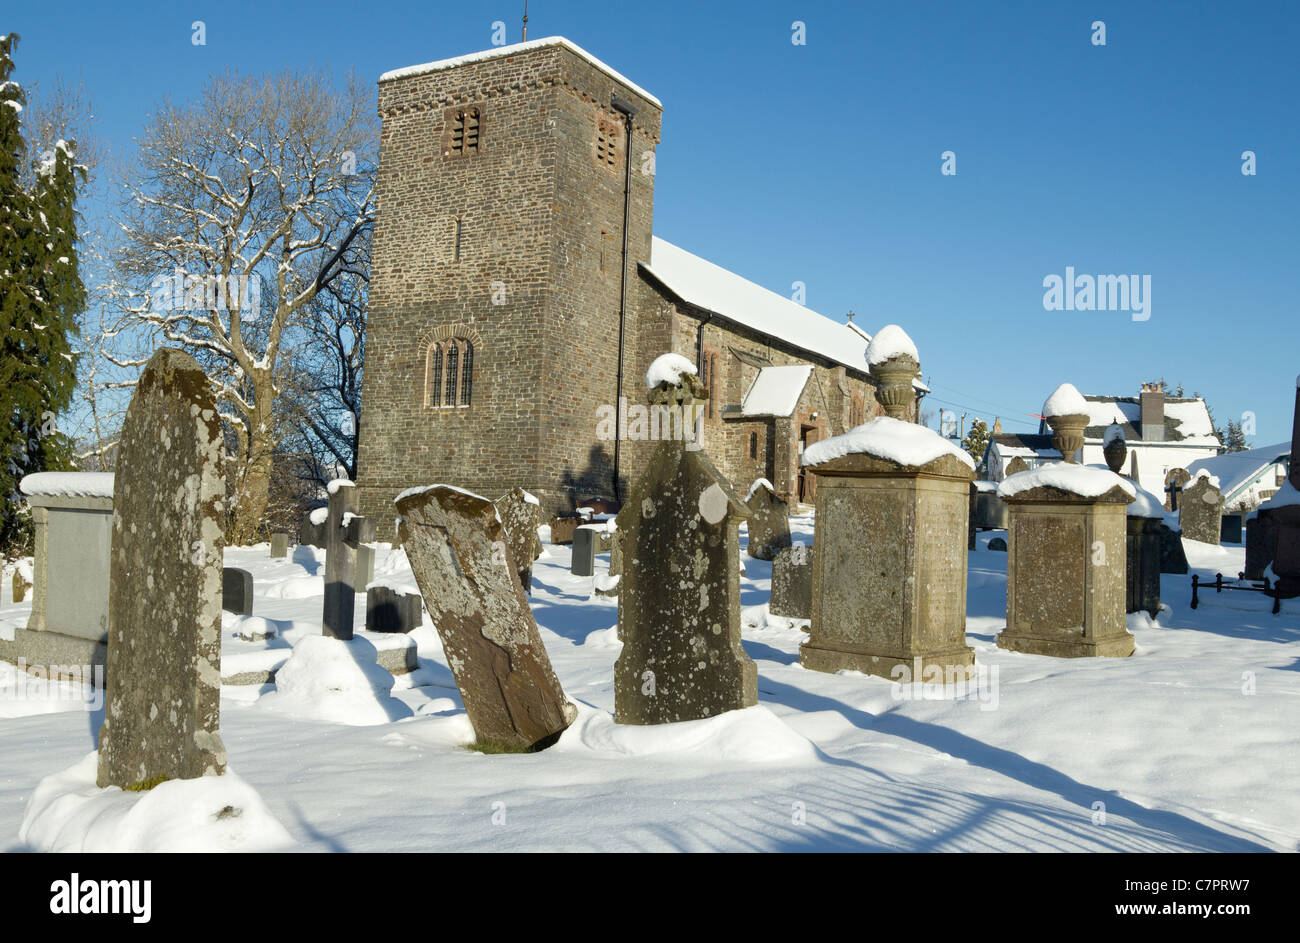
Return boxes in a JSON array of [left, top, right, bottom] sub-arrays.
[[99, 349, 226, 790]]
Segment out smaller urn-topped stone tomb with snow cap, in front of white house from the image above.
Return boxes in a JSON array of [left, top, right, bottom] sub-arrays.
[[997, 384, 1136, 658]]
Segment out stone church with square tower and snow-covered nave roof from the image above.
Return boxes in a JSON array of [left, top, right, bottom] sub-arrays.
[[358, 38, 926, 538]]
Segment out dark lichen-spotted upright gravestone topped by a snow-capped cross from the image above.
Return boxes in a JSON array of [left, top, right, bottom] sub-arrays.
[[614, 354, 758, 723]]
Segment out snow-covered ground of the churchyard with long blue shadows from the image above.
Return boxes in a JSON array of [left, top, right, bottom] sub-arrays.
[[0, 515, 1300, 851]]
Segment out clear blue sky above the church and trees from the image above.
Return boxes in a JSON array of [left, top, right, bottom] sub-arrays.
[[0, 0, 1300, 445]]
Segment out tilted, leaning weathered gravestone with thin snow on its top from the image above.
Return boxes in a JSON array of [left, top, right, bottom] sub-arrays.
[[395, 485, 577, 750]]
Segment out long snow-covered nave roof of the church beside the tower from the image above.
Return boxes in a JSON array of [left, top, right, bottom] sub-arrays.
[[642, 235, 871, 373]]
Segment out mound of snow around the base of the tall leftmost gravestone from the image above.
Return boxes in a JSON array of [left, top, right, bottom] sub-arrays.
[[18, 753, 293, 852]]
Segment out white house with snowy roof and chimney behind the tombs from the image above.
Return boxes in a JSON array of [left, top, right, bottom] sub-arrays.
[[985, 384, 1223, 496]]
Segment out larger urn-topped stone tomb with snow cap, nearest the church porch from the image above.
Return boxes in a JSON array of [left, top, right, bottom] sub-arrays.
[[800, 326, 975, 683]]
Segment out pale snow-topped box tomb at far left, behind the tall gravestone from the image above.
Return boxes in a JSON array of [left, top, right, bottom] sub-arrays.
[[0, 472, 113, 667]]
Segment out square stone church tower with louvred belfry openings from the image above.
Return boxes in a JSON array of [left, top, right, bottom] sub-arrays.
[[358, 39, 668, 540]]
